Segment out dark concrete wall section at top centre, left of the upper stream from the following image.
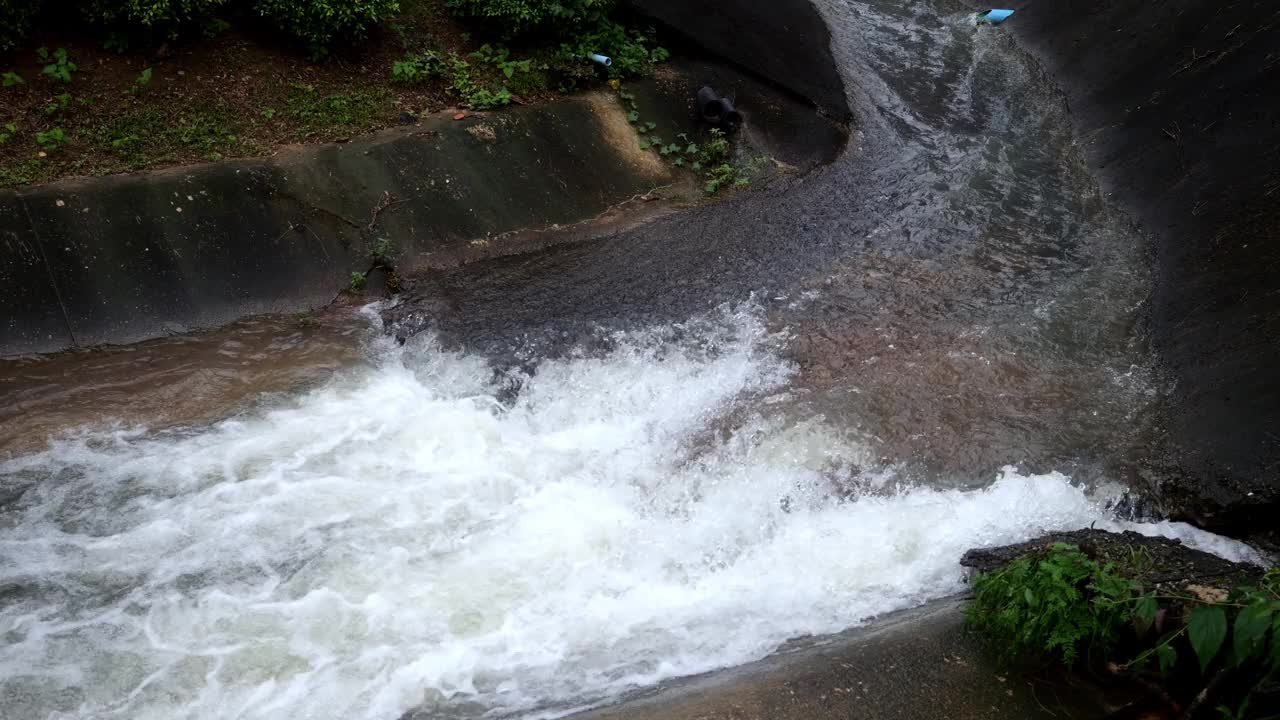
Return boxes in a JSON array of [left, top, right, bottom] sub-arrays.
[[628, 0, 851, 122]]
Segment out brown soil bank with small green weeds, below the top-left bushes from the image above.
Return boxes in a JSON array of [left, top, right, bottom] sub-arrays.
[[0, 0, 664, 188]]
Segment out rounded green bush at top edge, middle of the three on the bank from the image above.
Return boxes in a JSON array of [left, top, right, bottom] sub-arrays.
[[253, 0, 399, 58]]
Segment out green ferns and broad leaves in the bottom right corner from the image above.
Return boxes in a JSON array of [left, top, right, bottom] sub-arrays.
[[968, 543, 1280, 717]]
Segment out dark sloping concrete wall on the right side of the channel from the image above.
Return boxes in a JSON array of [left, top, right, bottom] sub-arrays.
[[1002, 0, 1280, 533]]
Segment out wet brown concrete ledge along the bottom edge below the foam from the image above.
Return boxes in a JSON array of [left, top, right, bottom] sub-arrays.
[[571, 600, 1111, 720]]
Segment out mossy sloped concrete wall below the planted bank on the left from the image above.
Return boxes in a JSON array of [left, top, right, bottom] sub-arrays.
[[0, 95, 668, 355]]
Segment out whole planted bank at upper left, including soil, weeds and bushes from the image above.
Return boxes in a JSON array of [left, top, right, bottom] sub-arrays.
[[0, 0, 667, 187]]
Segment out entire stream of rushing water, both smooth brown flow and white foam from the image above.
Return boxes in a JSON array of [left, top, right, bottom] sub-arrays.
[[0, 0, 1251, 720]]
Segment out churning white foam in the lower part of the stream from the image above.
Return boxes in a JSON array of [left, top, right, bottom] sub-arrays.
[[0, 303, 1259, 720]]
